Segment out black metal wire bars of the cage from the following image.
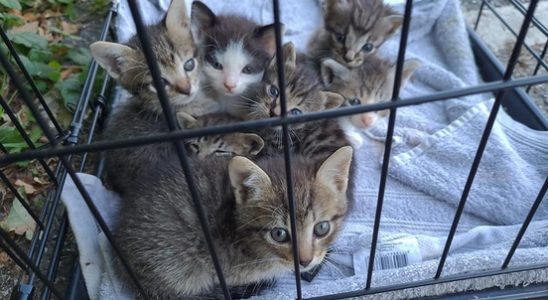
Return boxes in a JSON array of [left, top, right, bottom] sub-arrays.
[[0, 0, 548, 299]]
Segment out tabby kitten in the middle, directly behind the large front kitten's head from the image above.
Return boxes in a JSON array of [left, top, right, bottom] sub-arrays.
[[240, 43, 349, 159]]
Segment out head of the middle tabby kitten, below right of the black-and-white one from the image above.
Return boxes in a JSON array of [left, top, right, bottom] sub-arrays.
[[241, 43, 344, 130]]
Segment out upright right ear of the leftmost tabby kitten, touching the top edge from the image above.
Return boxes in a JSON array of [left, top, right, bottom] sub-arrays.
[[165, 0, 191, 46]]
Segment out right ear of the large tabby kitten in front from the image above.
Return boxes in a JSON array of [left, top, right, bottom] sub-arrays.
[[316, 146, 353, 193]]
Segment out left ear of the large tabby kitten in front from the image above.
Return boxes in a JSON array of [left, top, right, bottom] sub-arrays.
[[228, 156, 272, 204]]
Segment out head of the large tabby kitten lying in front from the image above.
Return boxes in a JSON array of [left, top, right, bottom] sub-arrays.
[[229, 146, 352, 272]]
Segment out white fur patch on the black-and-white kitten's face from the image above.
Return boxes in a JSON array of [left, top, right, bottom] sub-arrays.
[[204, 41, 263, 96]]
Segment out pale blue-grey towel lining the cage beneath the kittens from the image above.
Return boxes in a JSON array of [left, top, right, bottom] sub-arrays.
[[62, 0, 548, 299]]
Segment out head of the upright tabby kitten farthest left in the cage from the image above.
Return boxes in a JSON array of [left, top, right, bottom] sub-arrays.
[[90, 0, 200, 111]]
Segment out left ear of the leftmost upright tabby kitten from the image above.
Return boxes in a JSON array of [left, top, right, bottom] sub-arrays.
[[89, 42, 136, 79]]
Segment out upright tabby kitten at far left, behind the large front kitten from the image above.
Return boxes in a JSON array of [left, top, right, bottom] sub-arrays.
[[90, 0, 199, 194]]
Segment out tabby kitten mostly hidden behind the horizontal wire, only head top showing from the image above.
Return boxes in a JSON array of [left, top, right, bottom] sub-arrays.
[[177, 113, 264, 159]]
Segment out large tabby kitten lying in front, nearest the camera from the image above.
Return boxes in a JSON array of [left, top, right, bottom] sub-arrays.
[[115, 147, 352, 299]]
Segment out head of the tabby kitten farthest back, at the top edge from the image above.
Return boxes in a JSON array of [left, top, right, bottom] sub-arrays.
[[324, 0, 403, 67]]
